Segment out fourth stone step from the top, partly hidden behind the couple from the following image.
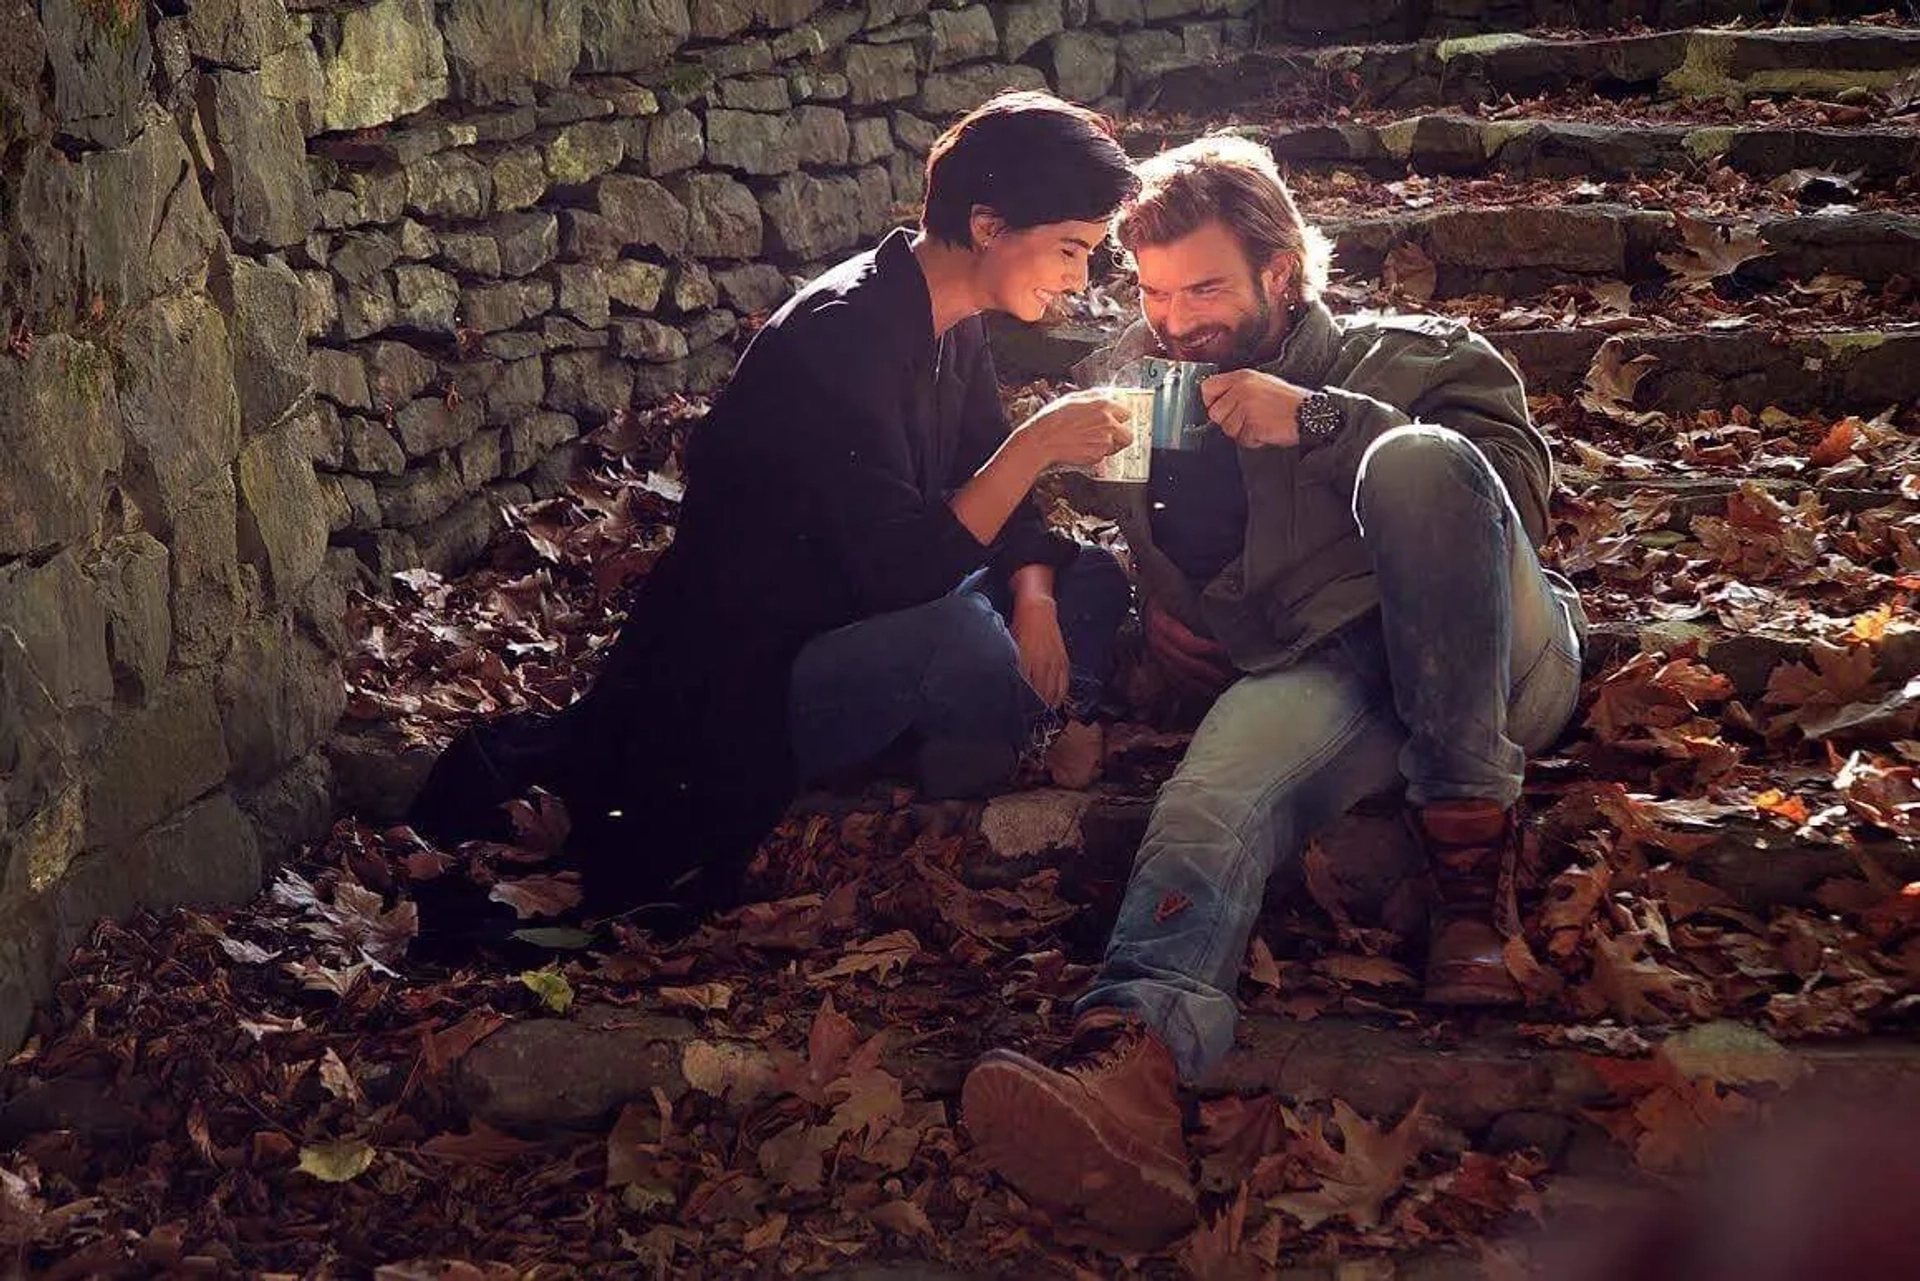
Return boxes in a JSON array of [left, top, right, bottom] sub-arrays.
[[987, 319, 1920, 413]]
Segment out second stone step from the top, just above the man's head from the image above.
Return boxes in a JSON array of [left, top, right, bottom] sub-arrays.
[[1125, 111, 1920, 190]]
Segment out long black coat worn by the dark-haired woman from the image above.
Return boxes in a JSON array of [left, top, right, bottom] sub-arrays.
[[413, 230, 1073, 925]]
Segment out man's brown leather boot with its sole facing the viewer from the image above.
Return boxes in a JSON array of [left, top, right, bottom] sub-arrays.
[[960, 1010, 1194, 1250]]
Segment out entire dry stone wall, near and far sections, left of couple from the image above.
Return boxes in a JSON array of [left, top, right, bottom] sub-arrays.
[[0, 0, 1279, 1043]]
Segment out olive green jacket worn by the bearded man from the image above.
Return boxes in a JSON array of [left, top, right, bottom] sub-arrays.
[[1075, 302, 1578, 672]]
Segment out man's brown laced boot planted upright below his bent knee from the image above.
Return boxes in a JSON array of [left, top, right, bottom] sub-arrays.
[[1413, 801, 1524, 1004]]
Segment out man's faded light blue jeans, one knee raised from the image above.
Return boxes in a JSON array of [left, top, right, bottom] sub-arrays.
[[1077, 424, 1584, 1081]]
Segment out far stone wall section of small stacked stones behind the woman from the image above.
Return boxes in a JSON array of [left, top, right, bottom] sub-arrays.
[[288, 0, 1252, 574]]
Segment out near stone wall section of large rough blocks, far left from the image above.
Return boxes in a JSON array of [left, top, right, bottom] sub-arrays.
[[0, 0, 344, 1045]]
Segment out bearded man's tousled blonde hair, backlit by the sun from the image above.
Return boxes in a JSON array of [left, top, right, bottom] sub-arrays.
[[1114, 134, 1332, 302]]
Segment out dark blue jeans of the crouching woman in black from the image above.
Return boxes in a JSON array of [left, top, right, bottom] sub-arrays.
[[789, 545, 1133, 782]]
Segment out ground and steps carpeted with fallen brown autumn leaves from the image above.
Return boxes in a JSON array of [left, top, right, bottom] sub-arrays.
[[0, 67, 1920, 1277]]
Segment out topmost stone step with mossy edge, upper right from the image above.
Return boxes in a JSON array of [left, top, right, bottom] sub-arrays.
[[1129, 25, 1920, 115]]
